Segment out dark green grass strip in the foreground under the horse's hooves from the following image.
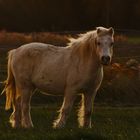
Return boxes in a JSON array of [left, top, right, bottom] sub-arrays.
[[0, 104, 140, 140]]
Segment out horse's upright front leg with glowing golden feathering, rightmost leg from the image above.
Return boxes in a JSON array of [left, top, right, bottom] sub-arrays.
[[78, 92, 96, 128]]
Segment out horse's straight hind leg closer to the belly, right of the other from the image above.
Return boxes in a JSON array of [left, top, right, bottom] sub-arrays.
[[21, 87, 33, 128]]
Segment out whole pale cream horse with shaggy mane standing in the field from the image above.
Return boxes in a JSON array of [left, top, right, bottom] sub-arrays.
[[4, 27, 114, 128]]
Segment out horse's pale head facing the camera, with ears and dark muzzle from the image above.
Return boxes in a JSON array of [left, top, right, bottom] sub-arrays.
[[95, 27, 114, 65]]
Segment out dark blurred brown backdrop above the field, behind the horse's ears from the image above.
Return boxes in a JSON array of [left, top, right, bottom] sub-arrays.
[[0, 0, 140, 32]]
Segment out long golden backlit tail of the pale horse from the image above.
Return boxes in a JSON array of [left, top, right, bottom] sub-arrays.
[[4, 50, 16, 110]]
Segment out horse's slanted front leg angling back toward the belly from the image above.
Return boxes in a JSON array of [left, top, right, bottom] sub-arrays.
[[53, 89, 76, 128]]
